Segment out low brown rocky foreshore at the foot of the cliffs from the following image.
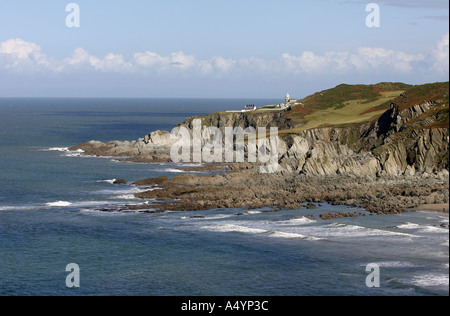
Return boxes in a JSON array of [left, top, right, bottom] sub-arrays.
[[122, 164, 449, 219]]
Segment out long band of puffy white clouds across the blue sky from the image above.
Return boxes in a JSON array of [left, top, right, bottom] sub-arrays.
[[0, 33, 449, 78]]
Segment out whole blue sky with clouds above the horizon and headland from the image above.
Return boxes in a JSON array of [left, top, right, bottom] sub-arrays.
[[0, 0, 449, 98]]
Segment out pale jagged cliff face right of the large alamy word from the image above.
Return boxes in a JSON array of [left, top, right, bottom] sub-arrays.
[[280, 102, 449, 177]]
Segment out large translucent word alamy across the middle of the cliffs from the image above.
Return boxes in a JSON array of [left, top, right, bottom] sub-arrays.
[[170, 119, 278, 173]]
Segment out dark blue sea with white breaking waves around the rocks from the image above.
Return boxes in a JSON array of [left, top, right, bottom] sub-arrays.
[[0, 99, 449, 296]]
